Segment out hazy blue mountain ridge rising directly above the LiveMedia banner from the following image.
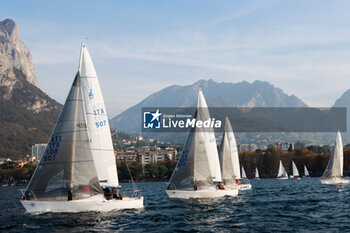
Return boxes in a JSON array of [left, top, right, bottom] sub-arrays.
[[112, 80, 307, 133]]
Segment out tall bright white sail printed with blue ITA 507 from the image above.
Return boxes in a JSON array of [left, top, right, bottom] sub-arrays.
[[79, 43, 119, 187]]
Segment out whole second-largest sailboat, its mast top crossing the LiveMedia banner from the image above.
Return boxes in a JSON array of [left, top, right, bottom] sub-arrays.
[[166, 89, 238, 199]]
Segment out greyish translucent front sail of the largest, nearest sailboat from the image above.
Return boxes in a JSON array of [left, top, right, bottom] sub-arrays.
[[25, 74, 100, 201]]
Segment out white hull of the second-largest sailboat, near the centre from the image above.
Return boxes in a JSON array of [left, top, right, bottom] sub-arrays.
[[165, 188, 238, 199]]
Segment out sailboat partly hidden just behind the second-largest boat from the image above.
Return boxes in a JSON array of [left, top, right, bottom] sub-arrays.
[[219, 117, 242, 194]]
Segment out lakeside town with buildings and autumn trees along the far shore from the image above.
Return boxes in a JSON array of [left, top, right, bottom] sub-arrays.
[[0, 130, 350, 186]]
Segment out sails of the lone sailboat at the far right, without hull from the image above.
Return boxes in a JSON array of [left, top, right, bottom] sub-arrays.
[[321, 131, 344, 180]]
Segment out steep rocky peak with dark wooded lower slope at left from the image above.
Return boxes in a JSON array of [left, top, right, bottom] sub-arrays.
[[0, 19, 61, 158]]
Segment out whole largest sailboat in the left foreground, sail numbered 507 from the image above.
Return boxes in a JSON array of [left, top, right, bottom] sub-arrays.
[[21, 43, 143, 213]]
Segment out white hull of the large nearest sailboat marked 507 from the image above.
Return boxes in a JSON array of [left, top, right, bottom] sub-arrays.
[[21, 195, 143, 213]]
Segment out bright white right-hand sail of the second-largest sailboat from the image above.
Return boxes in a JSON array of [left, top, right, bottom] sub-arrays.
[[197, 88, 222, 182]]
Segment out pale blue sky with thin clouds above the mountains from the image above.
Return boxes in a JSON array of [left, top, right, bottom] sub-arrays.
[[0, 0, 350, 117]]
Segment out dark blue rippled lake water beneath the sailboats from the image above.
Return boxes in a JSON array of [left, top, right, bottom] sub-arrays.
[[0, 178, 350, 232]]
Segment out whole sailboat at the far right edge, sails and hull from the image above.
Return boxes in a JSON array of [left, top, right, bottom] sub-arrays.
[[321, 131, 350, 184]]
